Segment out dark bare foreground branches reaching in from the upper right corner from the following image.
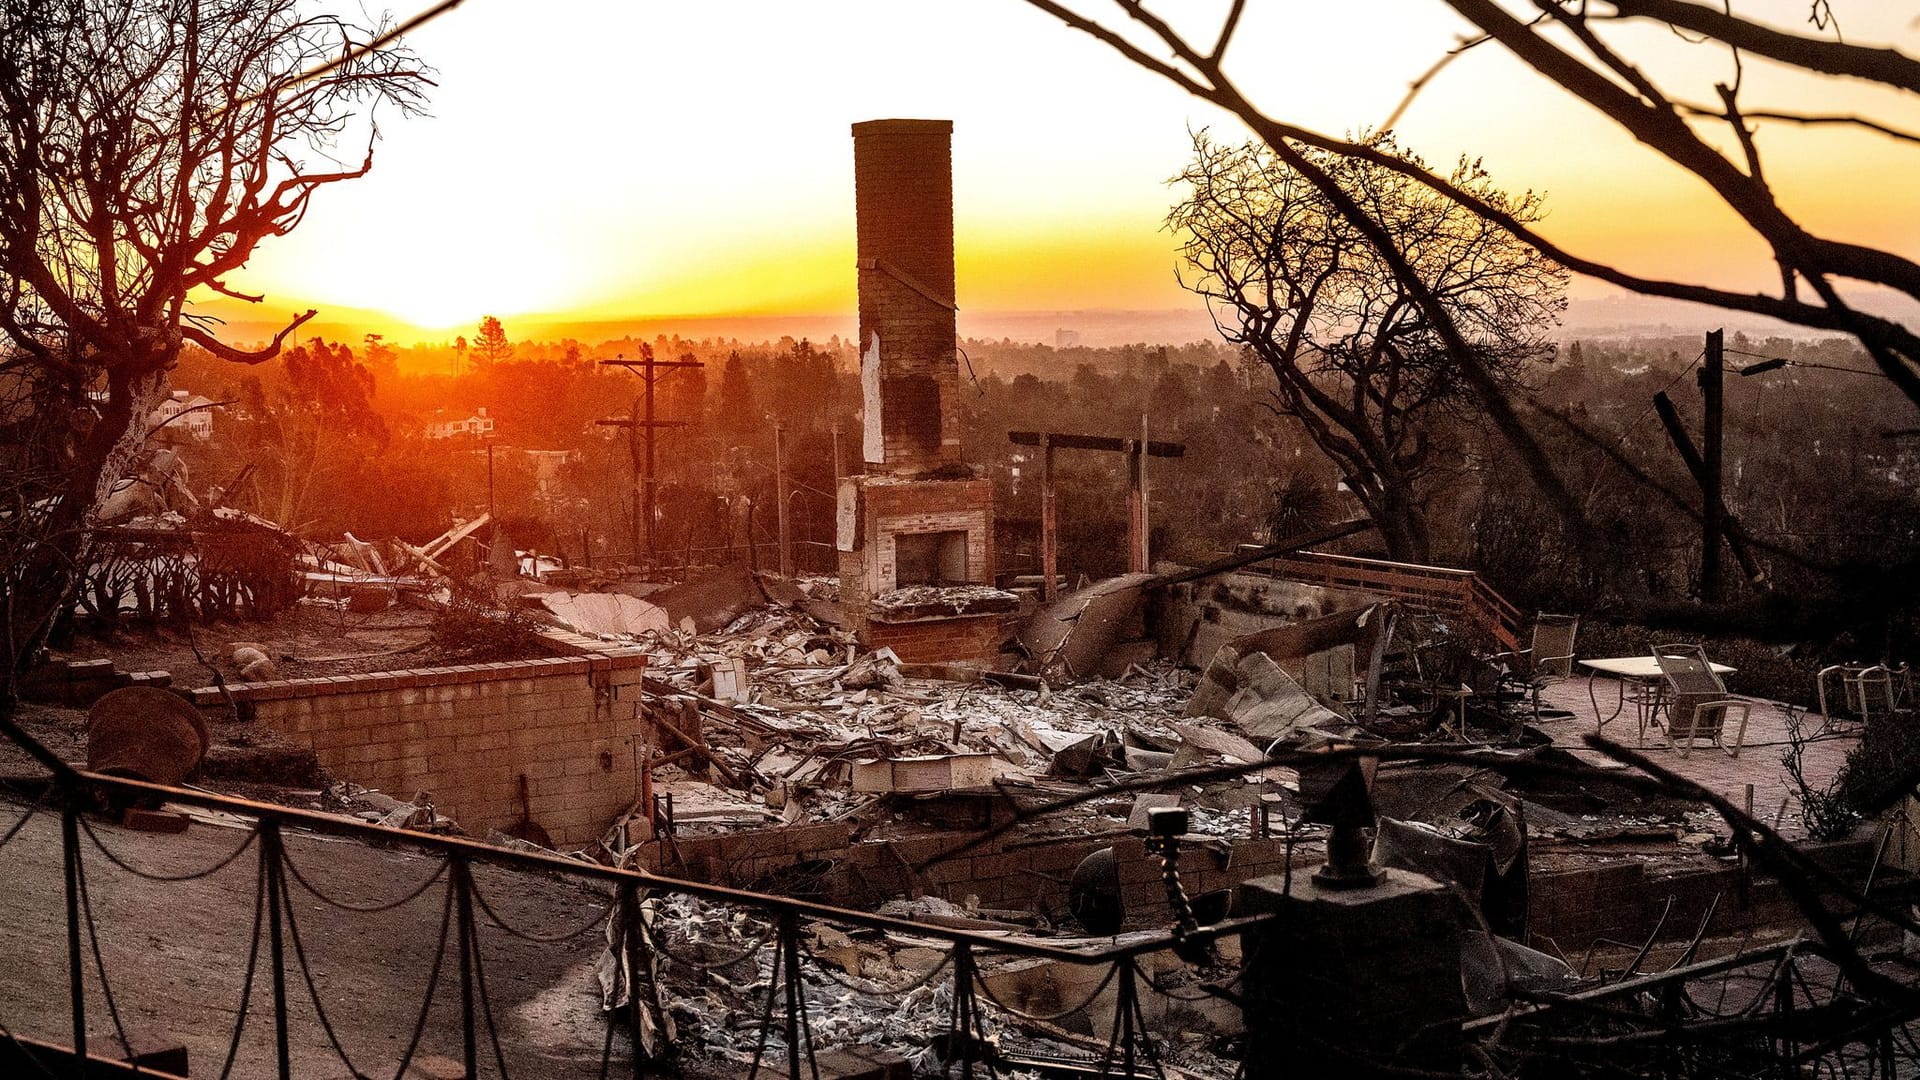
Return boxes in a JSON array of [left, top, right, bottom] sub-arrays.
[[1027, 0, 1920, 523]]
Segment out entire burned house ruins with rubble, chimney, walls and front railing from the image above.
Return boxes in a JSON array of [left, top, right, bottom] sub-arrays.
[[0, 119, 1920, 1080]]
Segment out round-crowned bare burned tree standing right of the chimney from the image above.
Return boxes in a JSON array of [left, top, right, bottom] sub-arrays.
[[1167, 133, 1567, 561]]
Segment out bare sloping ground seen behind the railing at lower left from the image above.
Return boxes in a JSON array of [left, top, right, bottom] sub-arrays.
[[0, 798, 626, 1078]]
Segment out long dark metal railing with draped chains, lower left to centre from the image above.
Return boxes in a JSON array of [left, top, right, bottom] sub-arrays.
[[0, 717, 1261, 1080]]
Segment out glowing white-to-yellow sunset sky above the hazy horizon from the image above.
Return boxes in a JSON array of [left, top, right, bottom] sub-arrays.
[[214, 0, 1920, 340]]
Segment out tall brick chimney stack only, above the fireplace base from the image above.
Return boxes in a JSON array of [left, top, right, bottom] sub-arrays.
[[852, 119, 960, 477]]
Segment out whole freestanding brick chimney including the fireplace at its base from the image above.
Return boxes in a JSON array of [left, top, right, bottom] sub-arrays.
[[835, 119, 1018, 667]]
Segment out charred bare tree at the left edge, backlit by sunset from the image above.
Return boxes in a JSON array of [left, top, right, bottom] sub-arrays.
[[0, 0, 424, 680]]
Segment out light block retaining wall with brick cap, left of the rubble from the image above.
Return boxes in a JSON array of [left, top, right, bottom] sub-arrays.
[[194, 650, 645, 847]]
